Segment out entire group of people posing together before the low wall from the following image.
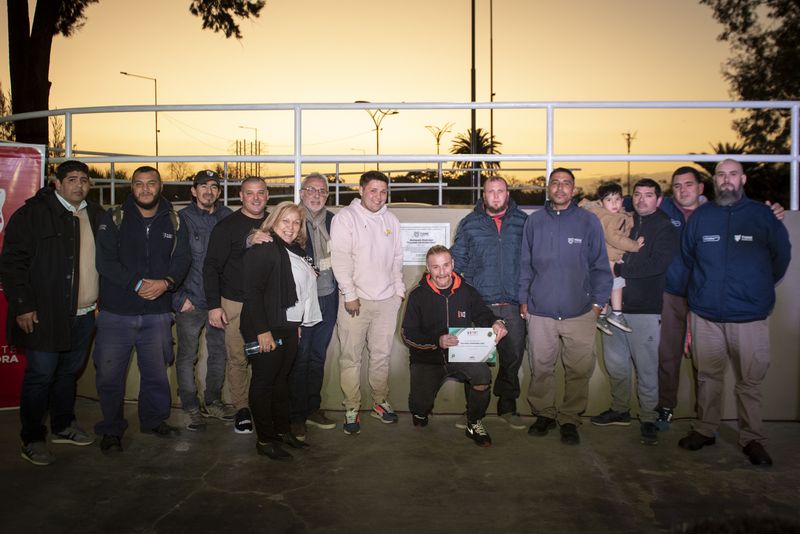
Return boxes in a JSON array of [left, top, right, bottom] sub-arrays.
[[0, 160, 790, 465]]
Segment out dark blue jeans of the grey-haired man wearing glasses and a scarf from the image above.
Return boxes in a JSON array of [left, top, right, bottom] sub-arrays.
[[289, 291, 339, 421]]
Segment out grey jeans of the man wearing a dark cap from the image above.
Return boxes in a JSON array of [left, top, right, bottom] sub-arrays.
[[175, 308, 225, 412]]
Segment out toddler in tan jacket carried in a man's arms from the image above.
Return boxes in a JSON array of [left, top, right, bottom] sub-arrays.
[[580, 183, 644, 336]]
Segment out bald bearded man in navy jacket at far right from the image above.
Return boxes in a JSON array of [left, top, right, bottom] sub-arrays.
[[678, 159, 791, 466]]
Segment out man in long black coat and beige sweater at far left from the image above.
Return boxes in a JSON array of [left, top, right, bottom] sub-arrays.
[[0, 160, 103, 465]]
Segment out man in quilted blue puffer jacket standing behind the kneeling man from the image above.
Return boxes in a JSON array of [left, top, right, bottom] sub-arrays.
[[452, 176, 527, 430]]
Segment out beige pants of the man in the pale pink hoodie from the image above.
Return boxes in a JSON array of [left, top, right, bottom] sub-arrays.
[[336, 295, 402, 410]]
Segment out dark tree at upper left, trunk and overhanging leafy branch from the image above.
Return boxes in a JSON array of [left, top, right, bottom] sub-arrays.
[[7, 0, 265, 144]]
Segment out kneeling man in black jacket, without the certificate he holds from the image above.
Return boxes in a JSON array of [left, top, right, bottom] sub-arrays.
[[402, 245, 507, 447]]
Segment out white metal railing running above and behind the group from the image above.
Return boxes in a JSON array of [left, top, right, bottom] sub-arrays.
[[0, 101, 800, 210]]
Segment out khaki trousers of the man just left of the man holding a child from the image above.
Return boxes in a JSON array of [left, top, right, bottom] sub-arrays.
[[528, 311, 597, 425]]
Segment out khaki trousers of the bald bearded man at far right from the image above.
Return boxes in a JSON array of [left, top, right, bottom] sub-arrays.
[[690, 313, 769, 446]]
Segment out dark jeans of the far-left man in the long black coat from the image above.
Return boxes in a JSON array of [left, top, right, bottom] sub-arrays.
[[19, 312, 94, 444]]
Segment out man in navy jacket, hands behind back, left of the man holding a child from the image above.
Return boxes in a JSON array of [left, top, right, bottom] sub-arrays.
[[519, 168, 612, 445]]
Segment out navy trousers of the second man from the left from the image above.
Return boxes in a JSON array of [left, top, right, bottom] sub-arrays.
[[93, 311, 173, 436]]
